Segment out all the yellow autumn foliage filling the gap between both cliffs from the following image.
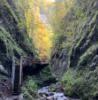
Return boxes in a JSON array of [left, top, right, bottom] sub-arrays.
[[23, 0, 74, 59]]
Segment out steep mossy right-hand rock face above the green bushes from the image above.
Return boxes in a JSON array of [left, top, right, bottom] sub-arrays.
[[51, 0, 98, 76]]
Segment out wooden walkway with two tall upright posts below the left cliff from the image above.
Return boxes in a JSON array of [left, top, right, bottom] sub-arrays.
[[11, 57, 48, 100]]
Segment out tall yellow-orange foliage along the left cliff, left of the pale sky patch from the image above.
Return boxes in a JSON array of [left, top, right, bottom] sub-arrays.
[[24, 0, 53, 59]]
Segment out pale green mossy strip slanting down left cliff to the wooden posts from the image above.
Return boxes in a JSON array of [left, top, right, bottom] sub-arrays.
[[0, 27, 23, 56]]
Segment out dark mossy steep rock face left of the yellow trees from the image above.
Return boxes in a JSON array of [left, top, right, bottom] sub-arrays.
[[0, 0, 33, 75]]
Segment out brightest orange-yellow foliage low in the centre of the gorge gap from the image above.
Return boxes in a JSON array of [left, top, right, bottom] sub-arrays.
[[33, 21, 53, 59]]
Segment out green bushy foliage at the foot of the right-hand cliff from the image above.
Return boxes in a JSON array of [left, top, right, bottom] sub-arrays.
[[62, 68, 98, 100]]
